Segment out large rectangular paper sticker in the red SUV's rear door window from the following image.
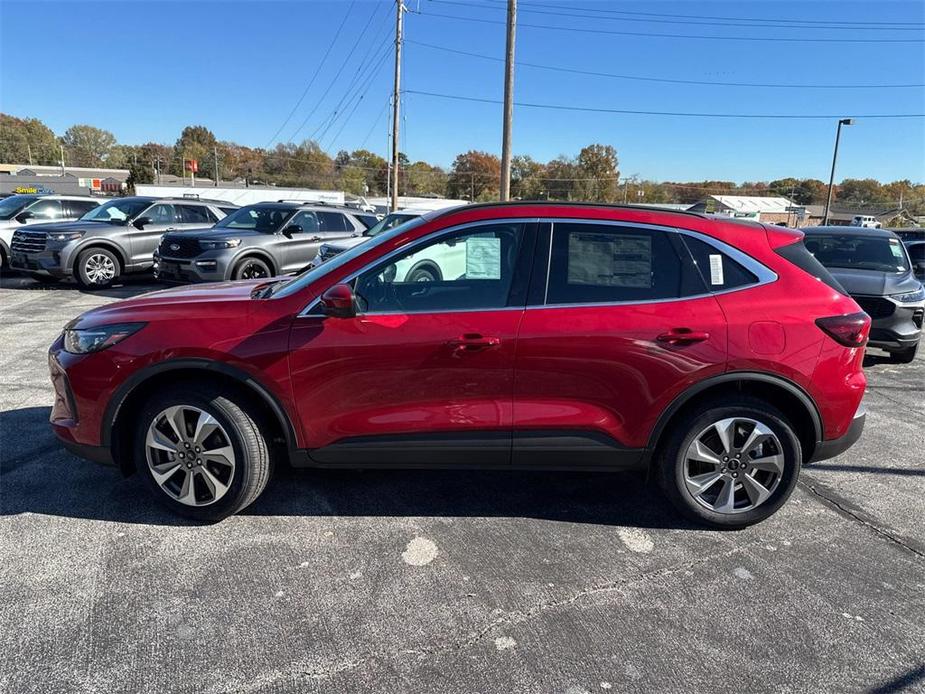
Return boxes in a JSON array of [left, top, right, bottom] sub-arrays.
[[568, 233, 652, 289]]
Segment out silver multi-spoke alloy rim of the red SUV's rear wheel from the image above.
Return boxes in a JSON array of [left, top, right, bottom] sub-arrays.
[[683, 417, 785, 514]]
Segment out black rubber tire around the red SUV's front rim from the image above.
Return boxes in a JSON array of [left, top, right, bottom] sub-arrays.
[[133, 384, 271, 522]]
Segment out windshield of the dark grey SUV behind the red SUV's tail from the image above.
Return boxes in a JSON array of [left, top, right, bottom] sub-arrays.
[[803, 234, 909, 273]]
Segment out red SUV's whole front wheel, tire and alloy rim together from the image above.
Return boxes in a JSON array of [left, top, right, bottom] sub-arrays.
[[135, 387, 270, 521]]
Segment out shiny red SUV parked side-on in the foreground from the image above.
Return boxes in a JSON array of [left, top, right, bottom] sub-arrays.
[[49, 203, 870, 527]]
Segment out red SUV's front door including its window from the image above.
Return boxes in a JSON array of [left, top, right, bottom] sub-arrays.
[[290, 222, 533, 466]]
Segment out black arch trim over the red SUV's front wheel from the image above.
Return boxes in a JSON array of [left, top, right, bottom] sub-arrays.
[[100, 358, 298, 451]]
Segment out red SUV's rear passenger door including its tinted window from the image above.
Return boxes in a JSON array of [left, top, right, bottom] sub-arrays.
[[513, 220, 726, 467]]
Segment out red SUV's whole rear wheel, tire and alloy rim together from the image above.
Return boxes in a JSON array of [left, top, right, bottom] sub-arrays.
[[656, 398, 802, 528]]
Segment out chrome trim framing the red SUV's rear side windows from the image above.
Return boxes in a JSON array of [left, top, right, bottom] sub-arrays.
[[527, 217, 778, 310]]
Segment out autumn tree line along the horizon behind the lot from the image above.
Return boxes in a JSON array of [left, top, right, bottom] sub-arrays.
[[0, 114, 925, 213]]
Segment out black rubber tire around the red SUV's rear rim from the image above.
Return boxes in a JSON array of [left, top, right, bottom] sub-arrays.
[[654, 396, 803, 529]]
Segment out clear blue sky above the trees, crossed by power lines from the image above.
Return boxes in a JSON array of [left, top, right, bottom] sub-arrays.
[[0, 0, 925, 181]]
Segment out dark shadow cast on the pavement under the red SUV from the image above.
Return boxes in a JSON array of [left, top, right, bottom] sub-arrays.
[[0, 407, 698, 529]]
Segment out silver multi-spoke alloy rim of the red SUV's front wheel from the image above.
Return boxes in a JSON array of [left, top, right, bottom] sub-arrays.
[[145, 405, 235, 506]]
